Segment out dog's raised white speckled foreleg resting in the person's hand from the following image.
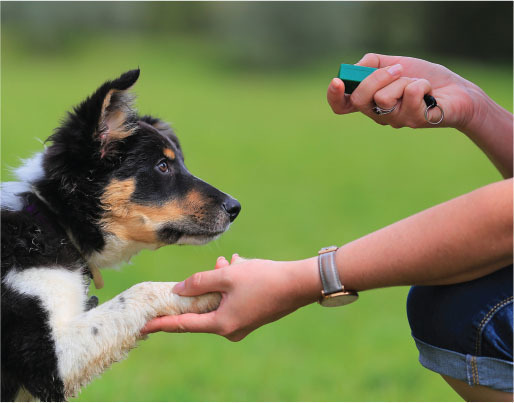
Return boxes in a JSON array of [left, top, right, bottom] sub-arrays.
[[55, 282, 220, 397]]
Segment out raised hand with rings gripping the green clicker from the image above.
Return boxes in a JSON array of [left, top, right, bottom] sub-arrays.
[[327, 53, 485, 131]]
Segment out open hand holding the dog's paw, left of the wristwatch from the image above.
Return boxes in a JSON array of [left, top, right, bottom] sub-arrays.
[[142, 254, 321, 341]]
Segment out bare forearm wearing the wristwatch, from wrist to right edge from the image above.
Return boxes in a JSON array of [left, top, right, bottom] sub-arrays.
[[289, 180, 512, 301]]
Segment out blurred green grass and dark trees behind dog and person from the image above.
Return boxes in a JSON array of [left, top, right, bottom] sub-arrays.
[[1, 2, 513, 401]]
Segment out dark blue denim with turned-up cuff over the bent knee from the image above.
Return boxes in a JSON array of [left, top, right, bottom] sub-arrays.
[[407, 265, 513, 392]]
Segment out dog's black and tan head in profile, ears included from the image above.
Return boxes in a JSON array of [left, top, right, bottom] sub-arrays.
[[37, 70, 241, 265]]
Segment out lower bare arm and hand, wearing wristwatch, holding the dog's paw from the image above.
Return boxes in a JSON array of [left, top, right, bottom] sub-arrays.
[[144, 179, 513, 341]]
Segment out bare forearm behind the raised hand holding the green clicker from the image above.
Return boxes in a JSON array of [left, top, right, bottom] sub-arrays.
[[458, 82, 513, 178]]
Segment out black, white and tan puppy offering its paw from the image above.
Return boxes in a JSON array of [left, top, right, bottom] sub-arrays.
[[1, 69, 241, 401]]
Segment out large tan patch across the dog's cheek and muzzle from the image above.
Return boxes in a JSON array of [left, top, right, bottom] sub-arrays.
[[101, 179, 205, 244]]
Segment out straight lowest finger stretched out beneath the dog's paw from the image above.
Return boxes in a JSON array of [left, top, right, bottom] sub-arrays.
[[141, 312, 218, 334]]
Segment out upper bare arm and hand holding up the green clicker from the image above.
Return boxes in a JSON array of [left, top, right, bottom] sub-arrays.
[[327, 53, 513, 178]]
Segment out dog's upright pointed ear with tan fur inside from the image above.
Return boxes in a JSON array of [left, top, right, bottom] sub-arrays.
[[74, 69, 139, 158]]
